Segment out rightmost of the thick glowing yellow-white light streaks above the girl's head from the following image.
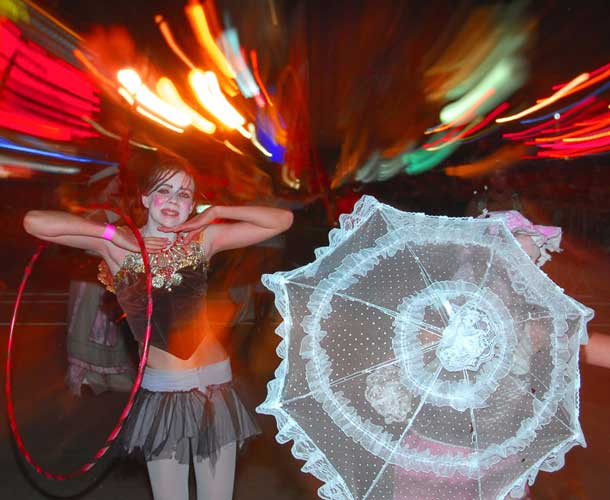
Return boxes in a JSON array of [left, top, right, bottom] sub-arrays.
[[188, 69, 250, 130]]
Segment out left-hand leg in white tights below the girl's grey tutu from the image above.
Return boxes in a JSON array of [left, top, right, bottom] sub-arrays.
[[146, 458, 189, 500]]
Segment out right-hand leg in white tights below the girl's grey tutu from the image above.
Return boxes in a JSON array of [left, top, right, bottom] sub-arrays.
[[194, 443, 236, 500]]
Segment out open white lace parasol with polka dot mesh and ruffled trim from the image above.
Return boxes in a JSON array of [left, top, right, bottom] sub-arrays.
[[258, 196, 593, 500]]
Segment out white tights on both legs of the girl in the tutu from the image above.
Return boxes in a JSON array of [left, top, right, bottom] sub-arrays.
[[146, 443, 236, 500]]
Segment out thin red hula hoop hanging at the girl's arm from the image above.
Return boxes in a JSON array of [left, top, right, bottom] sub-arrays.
[[4, 205, 153, 481]]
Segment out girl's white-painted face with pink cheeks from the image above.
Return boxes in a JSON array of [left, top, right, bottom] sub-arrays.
[[142, 172, 195, 227]]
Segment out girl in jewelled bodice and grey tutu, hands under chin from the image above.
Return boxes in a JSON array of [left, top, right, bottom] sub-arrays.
[[24, 156, 292, 500]]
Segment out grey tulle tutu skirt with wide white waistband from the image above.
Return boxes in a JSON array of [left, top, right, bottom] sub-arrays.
[[119, 361, 261, 464]]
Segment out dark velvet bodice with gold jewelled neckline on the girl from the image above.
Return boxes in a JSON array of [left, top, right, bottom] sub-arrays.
[[98, 242, 208, 359]]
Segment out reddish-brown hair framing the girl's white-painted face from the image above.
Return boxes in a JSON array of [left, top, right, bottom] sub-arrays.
[[125, 151, 209, 224]]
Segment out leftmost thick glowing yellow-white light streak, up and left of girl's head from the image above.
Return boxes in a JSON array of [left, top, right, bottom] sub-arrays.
[[117, 69, 192, 132]]
